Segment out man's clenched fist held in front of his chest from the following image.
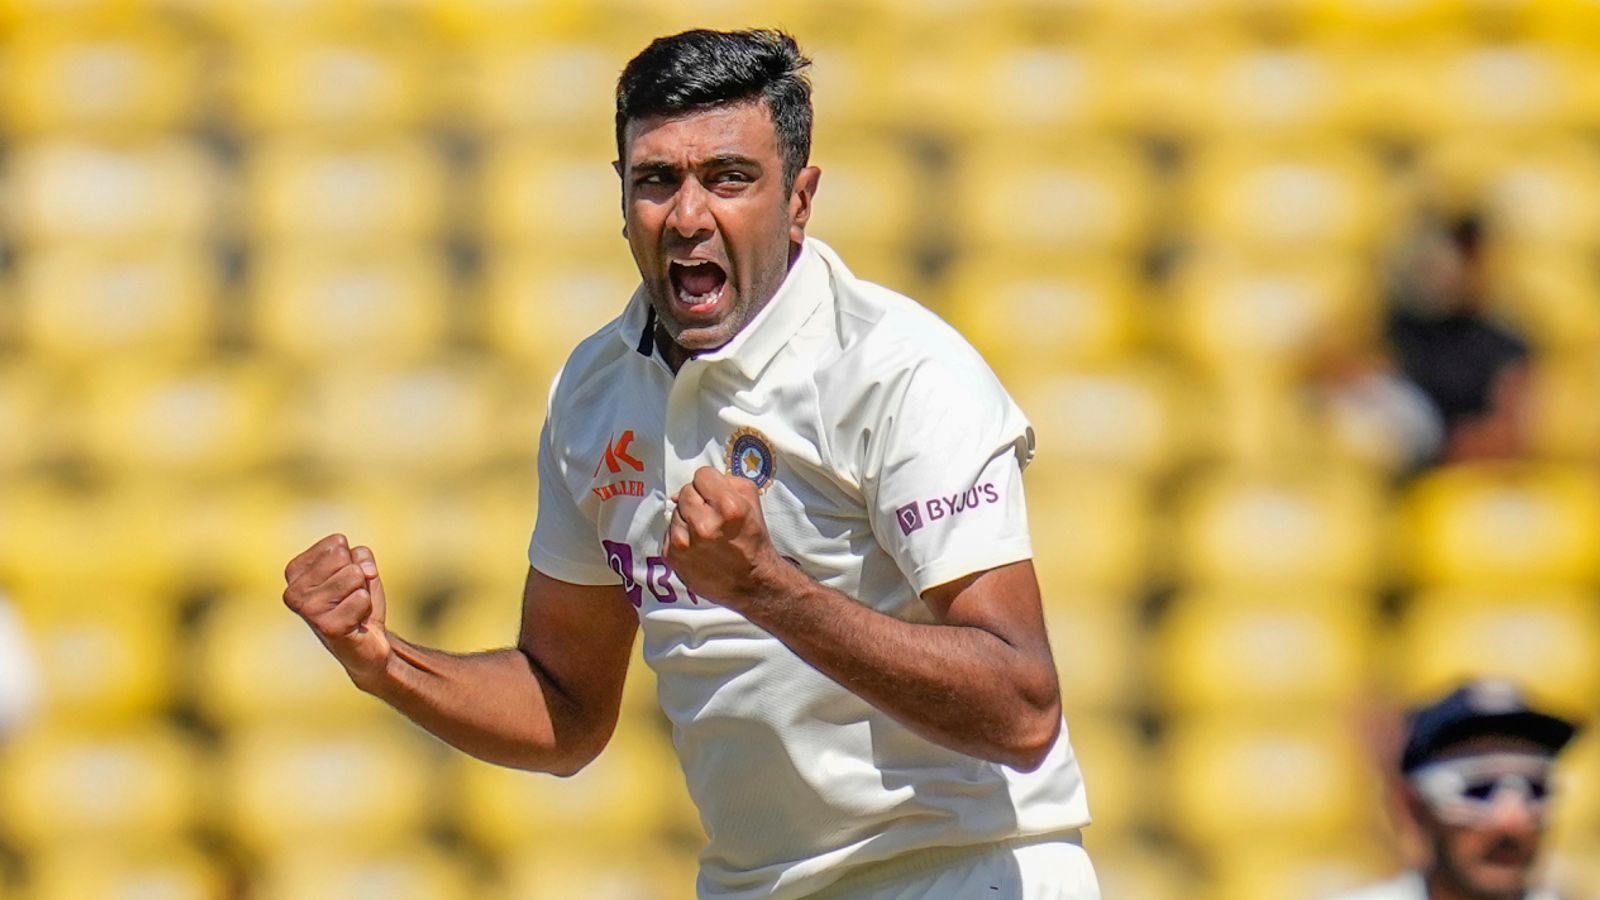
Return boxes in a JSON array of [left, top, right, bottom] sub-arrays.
[[662, 466, 784, 610]]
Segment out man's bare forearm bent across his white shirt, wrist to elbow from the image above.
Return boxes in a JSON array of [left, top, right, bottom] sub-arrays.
[[742, 560, 1061, 769]]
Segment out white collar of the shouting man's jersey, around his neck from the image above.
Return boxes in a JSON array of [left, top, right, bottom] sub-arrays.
[[619, 237, 830, 378]]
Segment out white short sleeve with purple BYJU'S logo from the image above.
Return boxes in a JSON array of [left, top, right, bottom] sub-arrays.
[[864, 351, 1034, 594]]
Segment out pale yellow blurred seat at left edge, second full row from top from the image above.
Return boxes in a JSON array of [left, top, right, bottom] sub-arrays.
[[6, 139, 218, 248]]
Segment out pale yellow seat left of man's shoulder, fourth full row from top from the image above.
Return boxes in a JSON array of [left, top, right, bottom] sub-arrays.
[[301, 360, 501, 476]]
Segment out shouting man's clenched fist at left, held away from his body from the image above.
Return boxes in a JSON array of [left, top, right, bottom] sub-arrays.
[[283, 535, 394, 692]]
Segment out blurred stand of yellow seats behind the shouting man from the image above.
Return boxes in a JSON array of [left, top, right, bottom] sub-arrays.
[[0, 0, 1600, 900]]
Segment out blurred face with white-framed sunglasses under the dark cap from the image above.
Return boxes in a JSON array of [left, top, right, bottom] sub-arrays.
[[1413, 738, 1549, 900]]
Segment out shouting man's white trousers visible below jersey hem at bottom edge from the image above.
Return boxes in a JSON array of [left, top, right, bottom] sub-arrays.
[[819, 841, 1099, 900]]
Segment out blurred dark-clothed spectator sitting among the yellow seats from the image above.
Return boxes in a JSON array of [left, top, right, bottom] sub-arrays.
[[1389, 215, 1528, 463]]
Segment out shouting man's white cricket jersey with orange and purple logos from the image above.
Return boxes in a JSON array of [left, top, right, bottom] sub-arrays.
[[530, 239, 1090, 898]]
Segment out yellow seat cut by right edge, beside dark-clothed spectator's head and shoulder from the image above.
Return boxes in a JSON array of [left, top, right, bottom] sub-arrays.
[[1493, 245, 1600, 355]]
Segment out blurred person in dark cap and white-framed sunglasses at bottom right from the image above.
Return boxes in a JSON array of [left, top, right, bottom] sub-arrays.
[[1341, 679, 1578, 900]]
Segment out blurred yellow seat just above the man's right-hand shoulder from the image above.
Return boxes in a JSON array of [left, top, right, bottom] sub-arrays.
[[946, 256, 1144, 378]]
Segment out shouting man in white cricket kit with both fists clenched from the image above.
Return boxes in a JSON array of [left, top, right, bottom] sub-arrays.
[[285, 30, 1099, 900]]
